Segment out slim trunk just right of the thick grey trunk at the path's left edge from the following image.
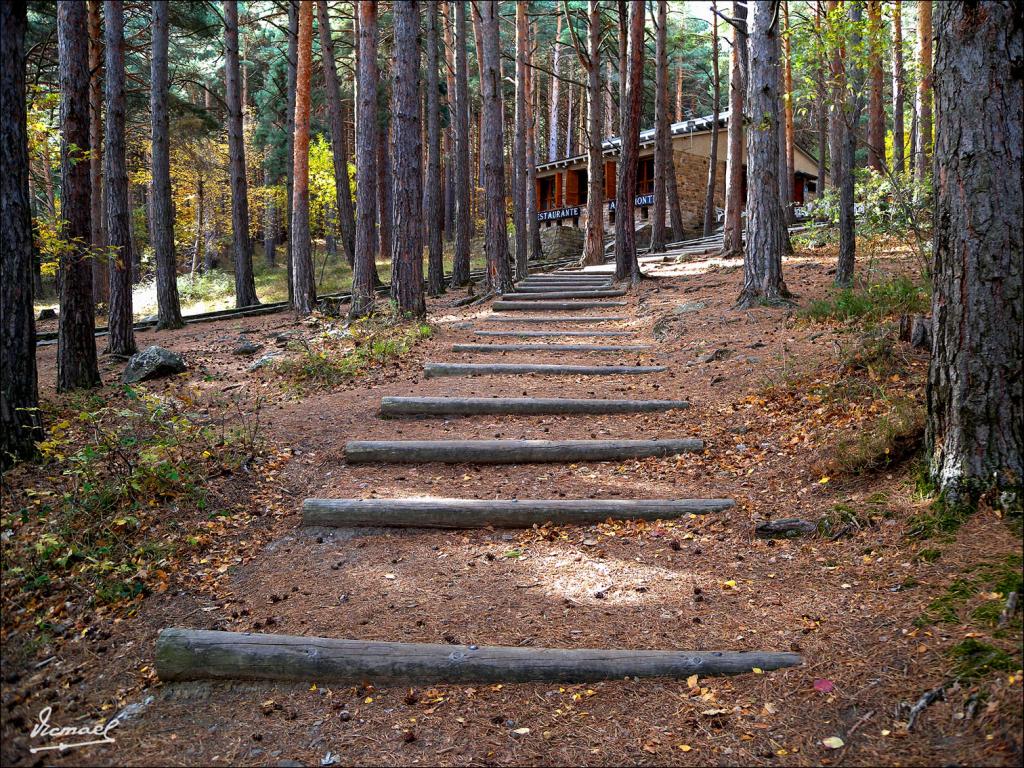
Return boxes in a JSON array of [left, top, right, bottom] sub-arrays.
[[423, 0, 444, 296]]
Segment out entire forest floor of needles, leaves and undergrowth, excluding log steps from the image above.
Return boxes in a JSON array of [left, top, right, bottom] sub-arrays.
[[2, 237, 1024, 765]]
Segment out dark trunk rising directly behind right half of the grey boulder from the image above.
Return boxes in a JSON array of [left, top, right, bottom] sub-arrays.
[[150, 0, 184, 330]]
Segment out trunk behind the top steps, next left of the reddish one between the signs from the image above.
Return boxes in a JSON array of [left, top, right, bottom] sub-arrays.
[[583, 0, 604, 266]]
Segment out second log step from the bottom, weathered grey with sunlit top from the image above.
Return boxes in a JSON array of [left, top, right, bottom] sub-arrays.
[[302, 498, 735, 528]]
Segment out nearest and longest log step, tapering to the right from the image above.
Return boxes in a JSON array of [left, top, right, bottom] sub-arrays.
[[156, 628, 803, 685]]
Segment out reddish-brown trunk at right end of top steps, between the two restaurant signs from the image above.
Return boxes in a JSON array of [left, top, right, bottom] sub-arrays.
[[615, 0, 644, 286]]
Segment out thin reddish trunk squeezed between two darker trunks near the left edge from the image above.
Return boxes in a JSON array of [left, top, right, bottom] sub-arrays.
[[87, 0, 111, 304]]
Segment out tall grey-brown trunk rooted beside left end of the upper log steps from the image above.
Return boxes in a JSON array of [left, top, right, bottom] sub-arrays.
[[473, 3, 512, 294]]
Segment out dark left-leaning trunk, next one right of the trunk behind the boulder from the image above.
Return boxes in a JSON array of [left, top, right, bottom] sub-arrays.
[[224, 0, 259, 306]]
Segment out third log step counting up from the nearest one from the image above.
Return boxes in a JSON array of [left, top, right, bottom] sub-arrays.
[[345, 439, 703, 464]]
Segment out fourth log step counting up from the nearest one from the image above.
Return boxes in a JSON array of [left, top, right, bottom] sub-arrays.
[[380, 397, 690, 417]]
